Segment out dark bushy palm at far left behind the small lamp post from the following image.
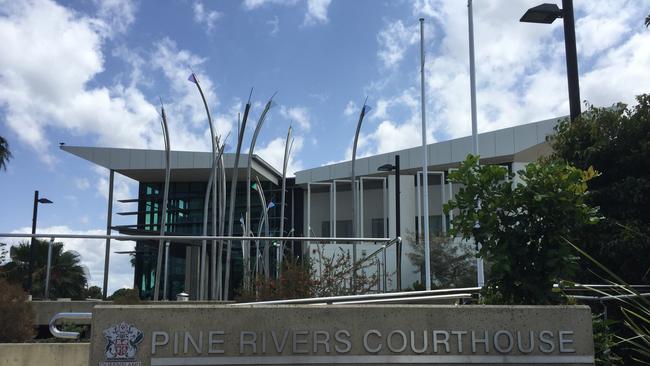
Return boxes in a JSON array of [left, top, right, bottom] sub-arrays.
[[0, 239, 88, 300]]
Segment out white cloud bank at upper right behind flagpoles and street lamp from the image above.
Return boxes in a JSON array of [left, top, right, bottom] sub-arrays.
[[356, 0, 650, 156]]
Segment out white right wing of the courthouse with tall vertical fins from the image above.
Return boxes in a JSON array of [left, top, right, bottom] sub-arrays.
[[295, 118, 561, 291]]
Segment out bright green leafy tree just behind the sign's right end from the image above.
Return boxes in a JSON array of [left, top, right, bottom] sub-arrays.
[[445, 155, 597, 304]]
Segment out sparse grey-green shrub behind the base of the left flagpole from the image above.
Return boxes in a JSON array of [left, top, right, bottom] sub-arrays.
[[408, 235, 476, 288]]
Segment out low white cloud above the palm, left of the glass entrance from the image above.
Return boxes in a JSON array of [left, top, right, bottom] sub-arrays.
[[8, 225, 135, 294]]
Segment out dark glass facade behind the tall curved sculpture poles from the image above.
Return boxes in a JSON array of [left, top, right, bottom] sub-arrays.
[[130, 182, 290, 300]]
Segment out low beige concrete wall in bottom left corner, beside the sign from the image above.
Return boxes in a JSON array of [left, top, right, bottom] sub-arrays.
[[0, 343, 90, 366]]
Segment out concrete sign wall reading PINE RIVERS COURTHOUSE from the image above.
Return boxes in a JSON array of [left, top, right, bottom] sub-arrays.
[[90, 305, 594, 366]]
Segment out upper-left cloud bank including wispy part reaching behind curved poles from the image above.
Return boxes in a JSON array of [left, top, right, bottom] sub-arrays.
[[0, 0, 232, 163]]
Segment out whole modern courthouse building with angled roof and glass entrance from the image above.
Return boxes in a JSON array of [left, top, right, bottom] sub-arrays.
[[61, 119, 559, 299]]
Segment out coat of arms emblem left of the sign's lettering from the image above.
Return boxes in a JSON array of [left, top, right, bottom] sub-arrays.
[[103, 322, 144, 362]]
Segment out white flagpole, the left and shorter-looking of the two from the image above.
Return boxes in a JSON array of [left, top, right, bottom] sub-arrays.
[[420, 18, 431, 290]]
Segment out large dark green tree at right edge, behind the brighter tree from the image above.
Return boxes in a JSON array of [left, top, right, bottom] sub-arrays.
[[549, 94, 650, 284]]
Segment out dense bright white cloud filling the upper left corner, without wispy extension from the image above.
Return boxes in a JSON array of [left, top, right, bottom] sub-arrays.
[[0, 0, 156, 162]]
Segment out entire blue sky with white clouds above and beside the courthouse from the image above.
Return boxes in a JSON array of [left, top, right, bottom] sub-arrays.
[[0, 0, 650, 290]]
